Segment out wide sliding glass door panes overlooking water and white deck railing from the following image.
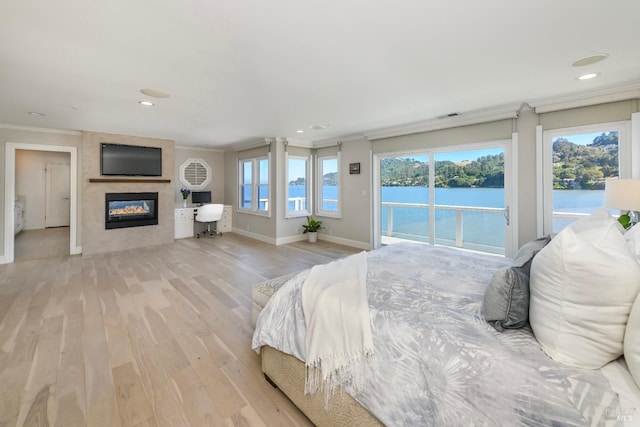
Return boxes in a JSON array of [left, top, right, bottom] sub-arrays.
[[374, 144, 511, 254]]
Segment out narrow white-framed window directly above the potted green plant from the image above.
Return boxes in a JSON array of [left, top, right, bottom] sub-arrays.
[[316, 153, 340, 218]]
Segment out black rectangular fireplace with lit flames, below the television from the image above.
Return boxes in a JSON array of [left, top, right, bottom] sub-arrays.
[[104, 193, 158, 230]]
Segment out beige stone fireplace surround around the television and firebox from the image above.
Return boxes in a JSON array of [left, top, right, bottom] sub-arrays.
[[81, 132, 175, 255]]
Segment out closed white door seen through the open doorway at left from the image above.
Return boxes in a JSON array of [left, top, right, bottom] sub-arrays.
[[45, 163, 70, 228]]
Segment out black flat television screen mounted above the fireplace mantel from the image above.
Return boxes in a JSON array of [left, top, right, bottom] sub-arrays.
[[100, 143, 162, 176]]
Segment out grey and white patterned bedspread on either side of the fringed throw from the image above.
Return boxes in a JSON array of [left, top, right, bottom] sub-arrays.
[[252, 243, 624, 426]]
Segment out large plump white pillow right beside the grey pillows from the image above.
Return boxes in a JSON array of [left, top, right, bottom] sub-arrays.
[[529, 210, 640, 369]]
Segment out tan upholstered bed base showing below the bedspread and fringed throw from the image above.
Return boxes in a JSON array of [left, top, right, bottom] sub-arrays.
[[261, 346, 382, 427]]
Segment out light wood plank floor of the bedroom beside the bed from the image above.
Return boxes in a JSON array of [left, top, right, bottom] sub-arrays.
[[0, 233, 358, 427]]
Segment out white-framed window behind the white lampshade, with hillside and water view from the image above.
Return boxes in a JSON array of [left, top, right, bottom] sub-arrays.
[[542, 123, 631, 234]]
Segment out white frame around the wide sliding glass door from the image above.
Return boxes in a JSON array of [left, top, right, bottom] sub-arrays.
[[372, 137, 518, 257]]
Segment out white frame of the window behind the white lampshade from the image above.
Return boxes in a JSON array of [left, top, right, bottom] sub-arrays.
[[536, 120, 634, 236]]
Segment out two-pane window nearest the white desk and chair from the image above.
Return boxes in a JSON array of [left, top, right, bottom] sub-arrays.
[[238, 157, 269, 215]]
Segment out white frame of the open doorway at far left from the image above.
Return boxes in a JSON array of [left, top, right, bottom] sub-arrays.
[[0, 142, 82, 264]]
